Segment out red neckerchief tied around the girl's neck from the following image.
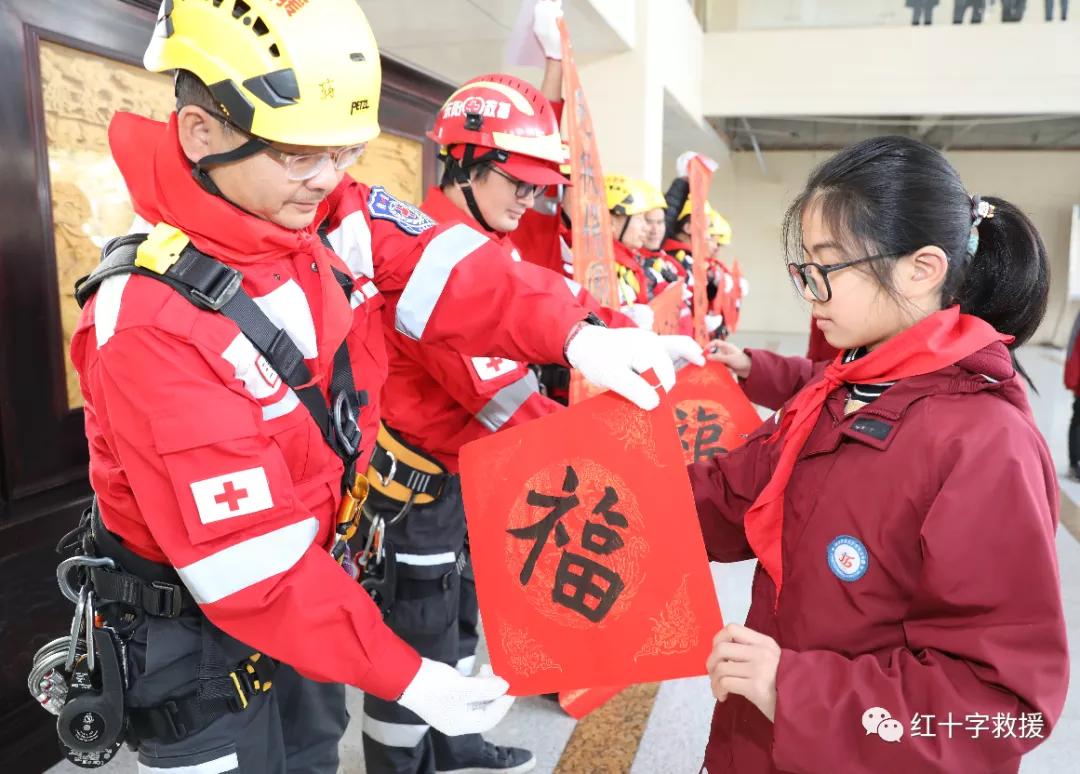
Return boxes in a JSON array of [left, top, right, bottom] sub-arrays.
[[744, 307, 1013, 603]]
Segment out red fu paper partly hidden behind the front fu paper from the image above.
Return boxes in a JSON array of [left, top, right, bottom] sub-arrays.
[[669, 363, 761, 465]]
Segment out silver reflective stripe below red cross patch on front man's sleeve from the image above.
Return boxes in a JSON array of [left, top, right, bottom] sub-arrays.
[[176, 516, 319, 605]]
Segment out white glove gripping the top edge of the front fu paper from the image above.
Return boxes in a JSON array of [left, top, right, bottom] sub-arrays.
[[566, 325, 705, 411]]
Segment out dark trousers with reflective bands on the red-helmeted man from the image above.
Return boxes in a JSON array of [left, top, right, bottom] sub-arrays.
[[364, 476, 484, 774]]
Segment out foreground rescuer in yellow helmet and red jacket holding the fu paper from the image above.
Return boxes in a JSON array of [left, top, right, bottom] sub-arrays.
[[58, 0, 700, 774]]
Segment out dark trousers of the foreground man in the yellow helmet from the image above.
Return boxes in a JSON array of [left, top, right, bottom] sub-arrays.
[[127, 616, 349, 774]]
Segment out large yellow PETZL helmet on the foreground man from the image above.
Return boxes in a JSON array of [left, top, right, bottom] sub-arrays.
[[143, 0, 382, 147]]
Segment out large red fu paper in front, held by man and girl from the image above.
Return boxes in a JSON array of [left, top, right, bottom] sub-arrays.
[[460, 394, 723, 695]]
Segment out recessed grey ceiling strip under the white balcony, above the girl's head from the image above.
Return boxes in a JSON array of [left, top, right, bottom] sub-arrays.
[[708, 114, 1080, 150]]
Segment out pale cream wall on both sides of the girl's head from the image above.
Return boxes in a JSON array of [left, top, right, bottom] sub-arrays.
[[713, 151, 1080, 343]]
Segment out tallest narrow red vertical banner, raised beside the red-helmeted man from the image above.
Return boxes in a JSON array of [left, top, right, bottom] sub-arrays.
[[558, 18, 619, 404]]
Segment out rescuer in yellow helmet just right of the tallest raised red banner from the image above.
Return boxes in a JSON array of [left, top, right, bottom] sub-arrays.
[[604, 175, 659, 328]]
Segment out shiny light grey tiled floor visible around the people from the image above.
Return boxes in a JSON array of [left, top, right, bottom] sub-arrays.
[[50, 335, 1080, 774]]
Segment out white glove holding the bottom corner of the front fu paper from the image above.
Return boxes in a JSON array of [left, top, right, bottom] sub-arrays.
[[397, 658, 514, 736]]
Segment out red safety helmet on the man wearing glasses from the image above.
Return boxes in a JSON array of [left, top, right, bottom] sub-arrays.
[[428, 74, 570, 186]]
